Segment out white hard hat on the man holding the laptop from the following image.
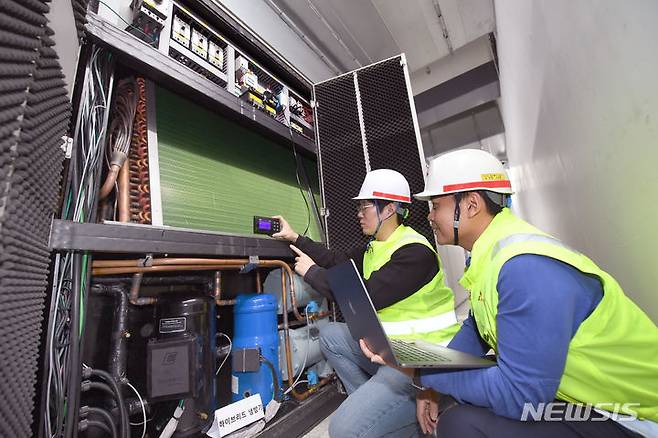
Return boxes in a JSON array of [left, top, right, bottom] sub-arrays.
[[414, 149, 512, 201]]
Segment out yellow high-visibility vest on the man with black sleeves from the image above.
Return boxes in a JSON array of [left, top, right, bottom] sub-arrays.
[[363, 225, 459, 344]]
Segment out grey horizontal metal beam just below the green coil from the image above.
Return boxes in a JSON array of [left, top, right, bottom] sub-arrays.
[[48, 219, 293, 259]]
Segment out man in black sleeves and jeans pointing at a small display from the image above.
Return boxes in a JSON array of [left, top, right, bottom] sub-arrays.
[[274, 169, 459, 438]]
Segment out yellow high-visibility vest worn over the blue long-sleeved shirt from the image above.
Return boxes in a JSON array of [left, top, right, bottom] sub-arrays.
[[460, 209, 658, 421]]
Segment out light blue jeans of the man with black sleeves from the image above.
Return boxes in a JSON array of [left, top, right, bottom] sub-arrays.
[[320, 322, 421, 438]]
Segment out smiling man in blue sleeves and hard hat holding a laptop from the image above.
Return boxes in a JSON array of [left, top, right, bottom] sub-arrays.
[[362, 149, 658, 438]]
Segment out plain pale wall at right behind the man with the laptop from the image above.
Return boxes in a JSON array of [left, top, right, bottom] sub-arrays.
[[495, 0, 658, 322]]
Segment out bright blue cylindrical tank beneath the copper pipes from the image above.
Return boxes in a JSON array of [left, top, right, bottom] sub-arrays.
[[231, 294, 281, 406]]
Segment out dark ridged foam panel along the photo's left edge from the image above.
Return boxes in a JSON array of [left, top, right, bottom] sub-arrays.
[[0, 0, 70, 437]]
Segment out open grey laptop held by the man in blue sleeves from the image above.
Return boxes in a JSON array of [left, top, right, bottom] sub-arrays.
[[327, 259, 495, 369]]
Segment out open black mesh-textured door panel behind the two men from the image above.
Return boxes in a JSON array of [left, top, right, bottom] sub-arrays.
[[314, 55, 434, 249]]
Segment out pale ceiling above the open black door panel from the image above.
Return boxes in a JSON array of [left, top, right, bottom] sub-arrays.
[[267, 0, 495, 89]]
